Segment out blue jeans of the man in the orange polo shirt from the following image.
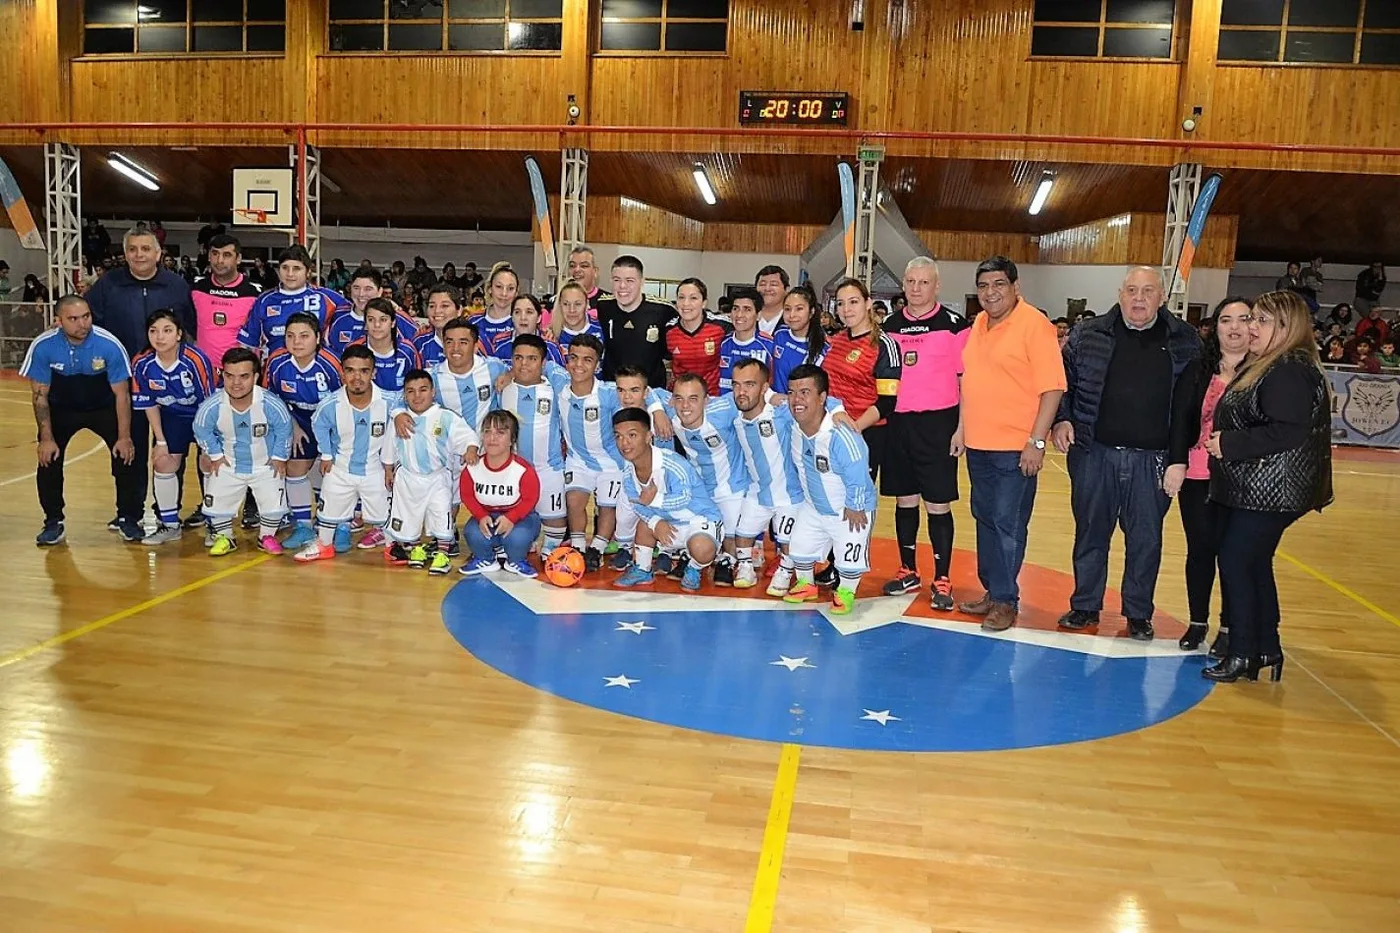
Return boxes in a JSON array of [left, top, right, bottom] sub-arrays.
[[967, 448, 1036, 605]]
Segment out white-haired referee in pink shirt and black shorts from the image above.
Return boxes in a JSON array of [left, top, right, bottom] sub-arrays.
[[879, 256, 970, 612]]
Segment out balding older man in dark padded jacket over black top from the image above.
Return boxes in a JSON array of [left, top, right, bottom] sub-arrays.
[[1051, 266, 1201, 642]]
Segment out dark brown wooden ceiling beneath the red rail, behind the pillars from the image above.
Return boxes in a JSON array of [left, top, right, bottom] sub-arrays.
[[0, 147, 1400, 262]]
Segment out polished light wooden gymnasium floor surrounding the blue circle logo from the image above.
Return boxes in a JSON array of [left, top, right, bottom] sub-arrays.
[[0, 369, 1400, 933]]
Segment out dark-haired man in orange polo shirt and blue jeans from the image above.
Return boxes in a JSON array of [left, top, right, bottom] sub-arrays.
[[958, 256, 1065, 632]]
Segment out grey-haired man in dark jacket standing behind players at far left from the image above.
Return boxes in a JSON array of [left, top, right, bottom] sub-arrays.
[[87, 227, 195, 530]]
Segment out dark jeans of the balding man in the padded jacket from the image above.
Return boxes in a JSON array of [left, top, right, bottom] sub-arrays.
[[1068, 444, 1172, 619]]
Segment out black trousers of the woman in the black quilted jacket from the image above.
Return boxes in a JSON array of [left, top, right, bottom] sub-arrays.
[[1219, 506, 1303, 657]]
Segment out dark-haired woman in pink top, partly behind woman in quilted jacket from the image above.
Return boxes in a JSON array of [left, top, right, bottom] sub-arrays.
[[1176, 298, 1252, 657]]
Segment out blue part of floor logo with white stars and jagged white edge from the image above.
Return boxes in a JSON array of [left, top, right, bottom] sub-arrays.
[[442, 577, 1210, 752]]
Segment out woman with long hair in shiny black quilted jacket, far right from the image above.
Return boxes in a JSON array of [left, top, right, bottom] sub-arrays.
[[1201, 291, 1331, 684]]
